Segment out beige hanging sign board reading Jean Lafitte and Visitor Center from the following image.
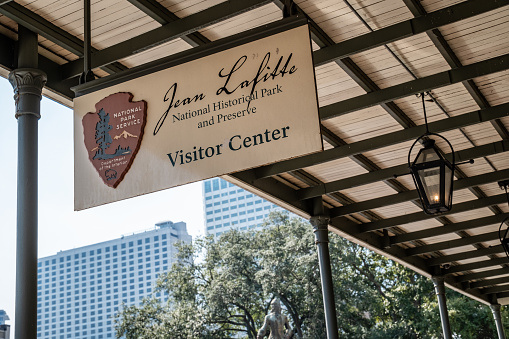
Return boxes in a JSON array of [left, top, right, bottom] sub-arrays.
[[74, 26, 323, 210]]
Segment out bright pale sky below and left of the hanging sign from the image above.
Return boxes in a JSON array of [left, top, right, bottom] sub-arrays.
[[0, 77, 204, 337]]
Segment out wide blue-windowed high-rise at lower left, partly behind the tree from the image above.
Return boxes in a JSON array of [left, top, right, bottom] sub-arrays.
[[37, 221, 191, 339]]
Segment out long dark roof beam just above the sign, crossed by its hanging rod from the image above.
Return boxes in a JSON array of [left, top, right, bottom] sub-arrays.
[[62, 0, 271, 77]]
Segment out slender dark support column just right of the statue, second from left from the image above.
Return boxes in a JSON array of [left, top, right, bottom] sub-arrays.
[[309, 216, 338, 339]]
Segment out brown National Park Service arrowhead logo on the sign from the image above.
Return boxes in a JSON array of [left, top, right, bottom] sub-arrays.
[[82, 92, 147, 188]]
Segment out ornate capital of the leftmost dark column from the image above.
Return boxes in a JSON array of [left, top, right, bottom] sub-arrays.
[[9, 68, 48, 119]]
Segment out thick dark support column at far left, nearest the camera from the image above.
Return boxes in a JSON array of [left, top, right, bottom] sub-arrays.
[[9, 26, 47, 339]]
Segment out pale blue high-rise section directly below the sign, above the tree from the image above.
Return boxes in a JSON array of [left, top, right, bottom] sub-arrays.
[[203, 178, 280, 235]]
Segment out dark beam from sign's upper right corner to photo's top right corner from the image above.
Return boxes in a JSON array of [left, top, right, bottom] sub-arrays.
[[314, 0, 508, 65]]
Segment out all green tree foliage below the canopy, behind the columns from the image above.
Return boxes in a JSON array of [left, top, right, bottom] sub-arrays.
[[116, 213, 509, 339]]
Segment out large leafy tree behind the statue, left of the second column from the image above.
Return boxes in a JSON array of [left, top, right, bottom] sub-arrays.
[[116, 214, 325, 339]]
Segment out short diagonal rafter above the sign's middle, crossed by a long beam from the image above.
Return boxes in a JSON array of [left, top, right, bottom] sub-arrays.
[[124, 0, 210, 47]]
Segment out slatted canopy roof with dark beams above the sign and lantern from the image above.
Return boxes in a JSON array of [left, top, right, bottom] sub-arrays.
[[0, 0, 509, 304]]
